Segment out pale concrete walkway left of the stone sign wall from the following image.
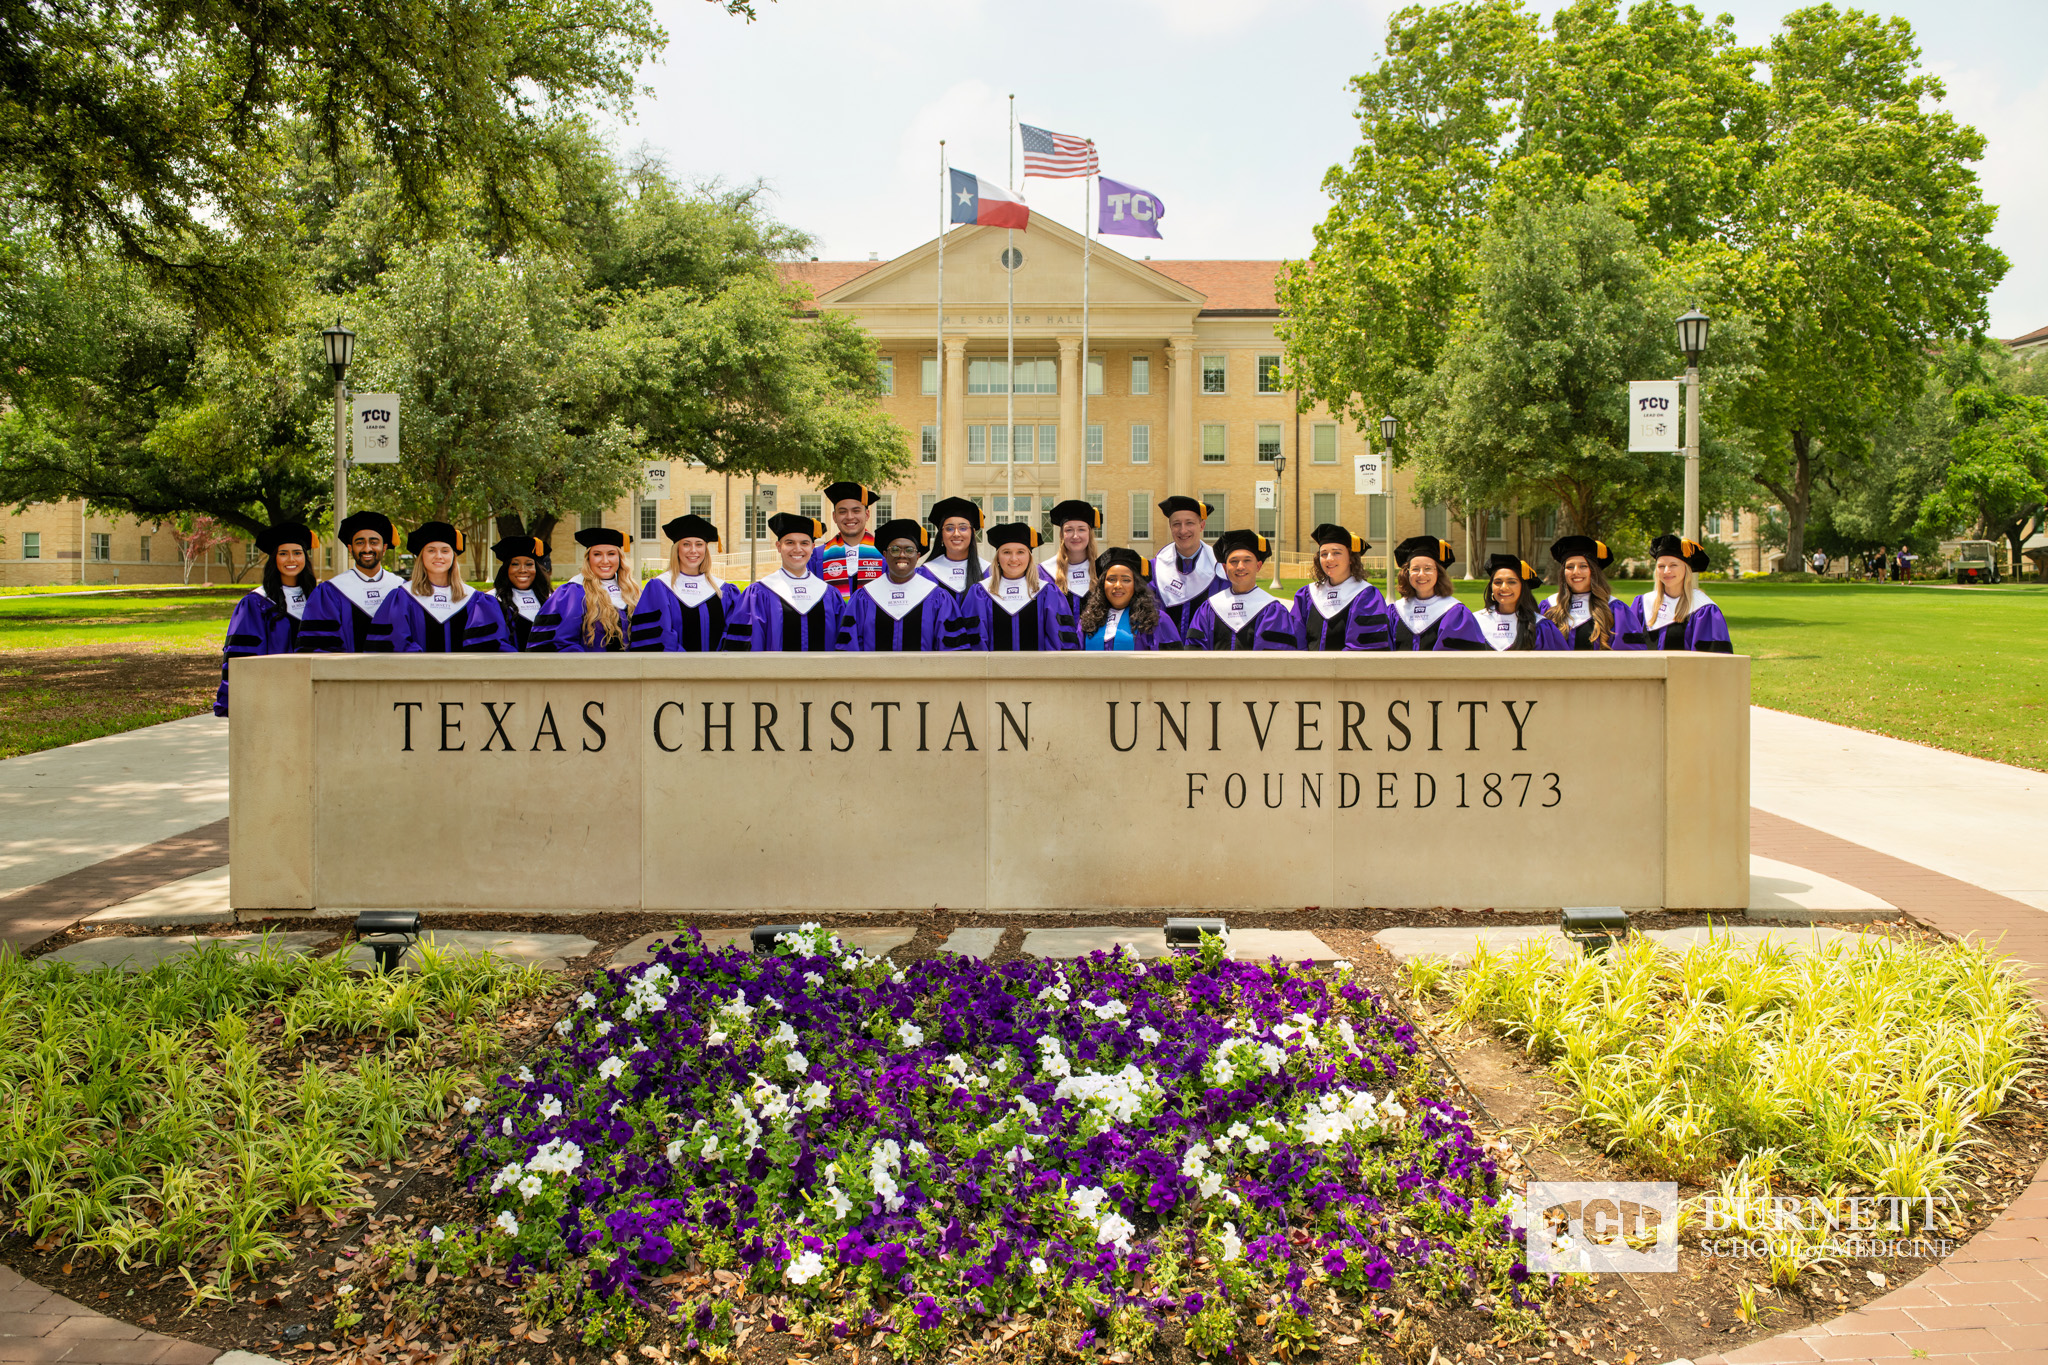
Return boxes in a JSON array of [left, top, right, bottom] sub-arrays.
[[0, 716, 227, 896]]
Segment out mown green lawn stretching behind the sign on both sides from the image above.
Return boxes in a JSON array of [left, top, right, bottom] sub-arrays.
[[0, 579, 2048, 772]]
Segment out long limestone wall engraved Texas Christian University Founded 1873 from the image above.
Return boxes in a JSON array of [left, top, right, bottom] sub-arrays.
[[229, 653, 1749, 915]]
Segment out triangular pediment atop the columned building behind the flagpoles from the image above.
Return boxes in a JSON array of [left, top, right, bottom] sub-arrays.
[[817, 215, 1206, 313]]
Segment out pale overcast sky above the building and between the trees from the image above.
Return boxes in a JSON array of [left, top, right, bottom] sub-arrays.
[[616, 0, 2048, 338]]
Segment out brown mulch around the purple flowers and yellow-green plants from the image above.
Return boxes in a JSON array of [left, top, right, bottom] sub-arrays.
[[0, 909, 2048, 1365]]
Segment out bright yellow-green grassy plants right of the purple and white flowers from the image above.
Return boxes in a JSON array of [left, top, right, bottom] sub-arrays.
[[1433, 931, 2040, 1195]]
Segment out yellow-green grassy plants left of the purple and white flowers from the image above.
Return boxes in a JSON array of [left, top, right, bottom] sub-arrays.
[[0, 941, 551, 1302]]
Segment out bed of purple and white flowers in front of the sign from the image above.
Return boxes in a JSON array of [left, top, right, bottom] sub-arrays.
[[444, 931, 1536, 1355]]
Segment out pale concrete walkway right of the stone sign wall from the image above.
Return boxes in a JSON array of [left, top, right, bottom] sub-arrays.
[[1749, 706, 2048, 911]]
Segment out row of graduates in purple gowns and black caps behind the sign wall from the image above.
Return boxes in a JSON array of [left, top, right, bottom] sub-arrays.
[[213, 483, 1729, 716]]
